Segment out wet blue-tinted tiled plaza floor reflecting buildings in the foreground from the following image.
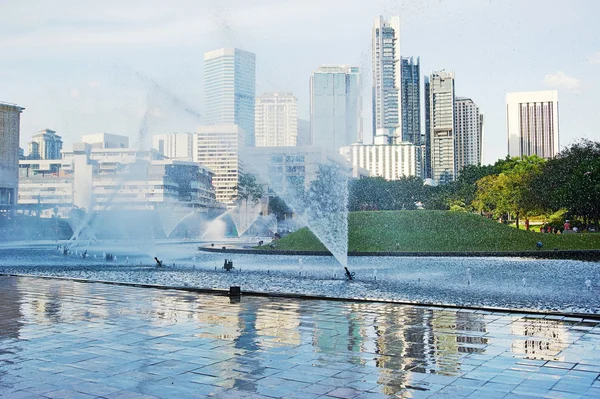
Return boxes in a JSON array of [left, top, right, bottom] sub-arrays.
[[0, 276, 600, 399]]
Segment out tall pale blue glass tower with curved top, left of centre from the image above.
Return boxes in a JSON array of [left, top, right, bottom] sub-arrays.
[[204, 48, 256, 147]]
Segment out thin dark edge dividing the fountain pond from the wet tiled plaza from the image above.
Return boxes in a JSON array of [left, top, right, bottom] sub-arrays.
[[0, 273, 600, 322]]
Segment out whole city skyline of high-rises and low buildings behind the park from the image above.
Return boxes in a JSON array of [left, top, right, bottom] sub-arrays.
[[0, 16, 558, 219]]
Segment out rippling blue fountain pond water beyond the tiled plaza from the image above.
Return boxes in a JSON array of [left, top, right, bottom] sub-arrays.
[[0, 242, 600, 314]]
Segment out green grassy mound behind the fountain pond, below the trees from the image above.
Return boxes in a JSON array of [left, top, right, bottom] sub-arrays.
[[275, 210, 600, 252]]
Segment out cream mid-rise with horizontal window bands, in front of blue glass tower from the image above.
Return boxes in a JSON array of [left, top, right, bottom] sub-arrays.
[[193, 125, 246, 207]]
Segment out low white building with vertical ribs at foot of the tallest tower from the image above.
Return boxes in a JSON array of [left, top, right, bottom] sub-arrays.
[[340, 142, 420, 180]]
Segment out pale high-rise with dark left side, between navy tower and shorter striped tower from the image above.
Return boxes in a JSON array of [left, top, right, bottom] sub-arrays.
[[425, 71, 456, 184]]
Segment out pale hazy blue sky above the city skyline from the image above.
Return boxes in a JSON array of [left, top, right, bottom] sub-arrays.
[[0, 0, 600, 164]]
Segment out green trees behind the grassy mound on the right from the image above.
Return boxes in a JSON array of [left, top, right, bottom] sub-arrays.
[[348, 140, 600, 226]]
